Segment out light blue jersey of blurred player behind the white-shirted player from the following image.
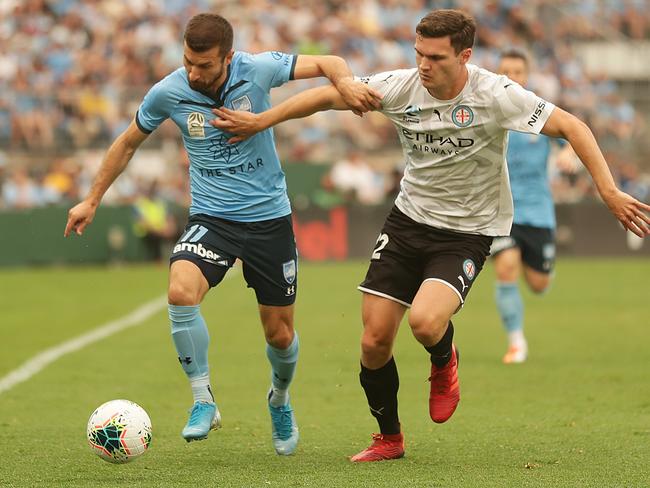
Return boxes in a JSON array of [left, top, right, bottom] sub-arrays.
[[506, 131, 564, 229]]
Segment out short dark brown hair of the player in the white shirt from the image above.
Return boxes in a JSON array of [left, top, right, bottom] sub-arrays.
[[415, 9, 476, 54]]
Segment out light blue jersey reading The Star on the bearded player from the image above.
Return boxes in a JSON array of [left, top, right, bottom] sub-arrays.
[[136, 52, 297, 222]]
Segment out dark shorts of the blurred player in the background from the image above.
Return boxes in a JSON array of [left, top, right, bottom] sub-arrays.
[[491, 224, 555, 274]]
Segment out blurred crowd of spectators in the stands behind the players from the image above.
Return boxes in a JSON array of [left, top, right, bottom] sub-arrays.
[[0, 0, 650, 209]]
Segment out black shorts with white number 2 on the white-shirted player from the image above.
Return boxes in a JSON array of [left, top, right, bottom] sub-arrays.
[[359, 207, 492, 307]]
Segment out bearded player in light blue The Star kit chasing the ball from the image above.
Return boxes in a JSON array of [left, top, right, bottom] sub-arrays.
[[64, 14, 379, 455]]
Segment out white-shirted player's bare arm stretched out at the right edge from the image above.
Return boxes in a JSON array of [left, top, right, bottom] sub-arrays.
[[542, 107, 650, 237]]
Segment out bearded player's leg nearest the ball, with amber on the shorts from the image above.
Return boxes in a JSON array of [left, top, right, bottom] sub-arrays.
[[168, 218, 234, 442]]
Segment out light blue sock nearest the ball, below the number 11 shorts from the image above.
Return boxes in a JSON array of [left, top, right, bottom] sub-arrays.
[[169, 304, 214, 402]]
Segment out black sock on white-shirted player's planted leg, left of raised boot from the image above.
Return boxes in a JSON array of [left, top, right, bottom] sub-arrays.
[[359, 357, 400, 434]]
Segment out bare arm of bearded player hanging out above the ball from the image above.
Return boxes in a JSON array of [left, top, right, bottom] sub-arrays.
[[63, 120, 149, 237]]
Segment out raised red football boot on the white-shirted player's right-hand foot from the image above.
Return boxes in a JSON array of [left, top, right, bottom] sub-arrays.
[[429, 345, 460, 424]]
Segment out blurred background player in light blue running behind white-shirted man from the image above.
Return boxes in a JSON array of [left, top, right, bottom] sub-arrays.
[[491, 50, 574, 364]]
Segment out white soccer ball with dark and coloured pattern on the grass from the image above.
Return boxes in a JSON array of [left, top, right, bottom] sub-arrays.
[[86, 400, 151, 464]]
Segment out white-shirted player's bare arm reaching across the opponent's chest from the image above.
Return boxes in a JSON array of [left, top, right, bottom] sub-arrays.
[[210, 82, 356, 144]]
